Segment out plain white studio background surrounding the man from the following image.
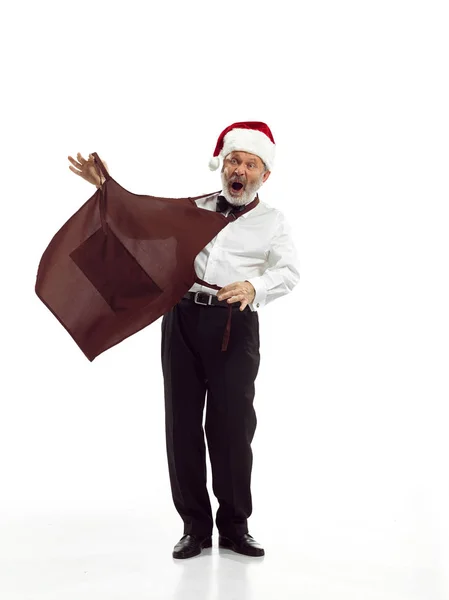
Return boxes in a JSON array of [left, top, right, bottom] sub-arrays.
[[0, 0, 449, 600]]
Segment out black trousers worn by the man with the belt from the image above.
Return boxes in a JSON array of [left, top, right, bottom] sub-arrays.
[[161, 299, 260, 536]]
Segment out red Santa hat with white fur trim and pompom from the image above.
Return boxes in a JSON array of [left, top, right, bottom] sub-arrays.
[[209, 121, 276, 171]]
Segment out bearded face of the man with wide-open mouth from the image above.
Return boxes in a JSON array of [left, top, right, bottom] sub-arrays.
[[221, 150, 270, 206]]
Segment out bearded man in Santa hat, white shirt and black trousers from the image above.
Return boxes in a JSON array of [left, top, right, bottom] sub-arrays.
[[69, 122, 299, 559]]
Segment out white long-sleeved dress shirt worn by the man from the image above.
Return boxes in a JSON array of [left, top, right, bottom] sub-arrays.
[[189, 193, 299, 311]]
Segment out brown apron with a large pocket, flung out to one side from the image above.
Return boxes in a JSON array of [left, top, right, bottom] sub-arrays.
[[35, 152, 259, 361]]
